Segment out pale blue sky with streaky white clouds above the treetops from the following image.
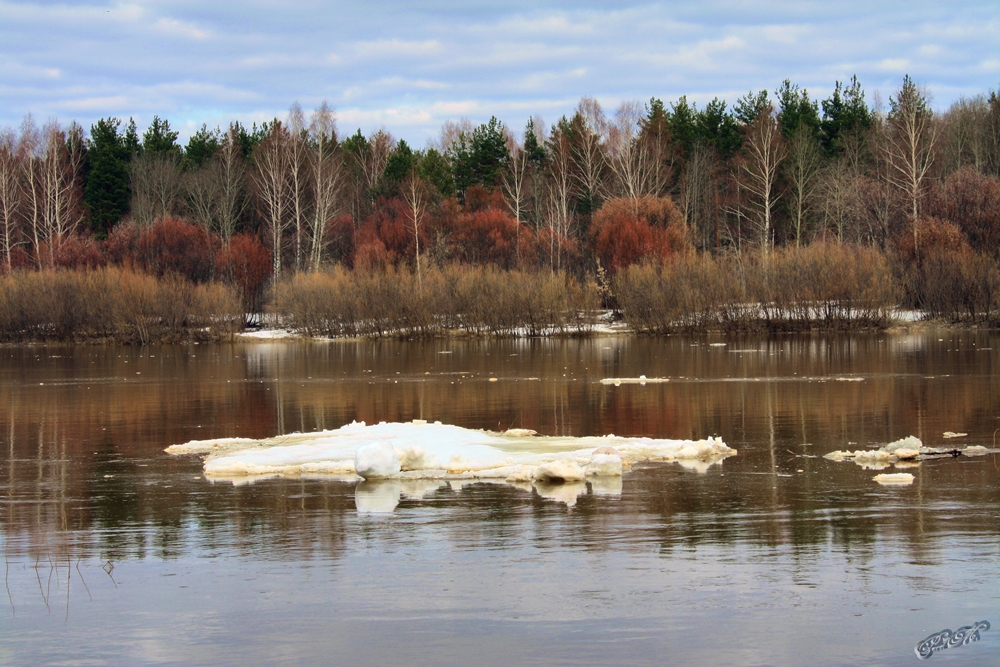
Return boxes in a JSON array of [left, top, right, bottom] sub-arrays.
[[0, 0, 1000, 146]]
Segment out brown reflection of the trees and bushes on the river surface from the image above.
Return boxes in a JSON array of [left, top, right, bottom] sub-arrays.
[[0, 334, 1000, 576]]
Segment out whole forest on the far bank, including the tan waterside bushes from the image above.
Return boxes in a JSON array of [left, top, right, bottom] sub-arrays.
[[0, 76, 1000, 342]]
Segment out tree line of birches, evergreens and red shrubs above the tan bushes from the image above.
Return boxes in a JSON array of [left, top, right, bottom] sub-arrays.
[[0, 76, 1000, 310]]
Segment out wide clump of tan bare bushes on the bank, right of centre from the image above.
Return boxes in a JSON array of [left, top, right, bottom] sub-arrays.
[[612, 243, 900, 333]]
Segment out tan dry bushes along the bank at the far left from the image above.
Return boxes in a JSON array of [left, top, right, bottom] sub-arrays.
[[0, 267, 242, 344]]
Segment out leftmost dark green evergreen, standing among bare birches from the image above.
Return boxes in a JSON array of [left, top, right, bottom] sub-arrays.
[[83, 118, 135, 238]]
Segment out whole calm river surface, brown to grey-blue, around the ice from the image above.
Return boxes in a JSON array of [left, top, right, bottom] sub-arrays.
[[0, 332, 1000, 665]]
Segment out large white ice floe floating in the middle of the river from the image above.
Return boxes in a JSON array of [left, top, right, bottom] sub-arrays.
[[166, 420, 736, 512]]
